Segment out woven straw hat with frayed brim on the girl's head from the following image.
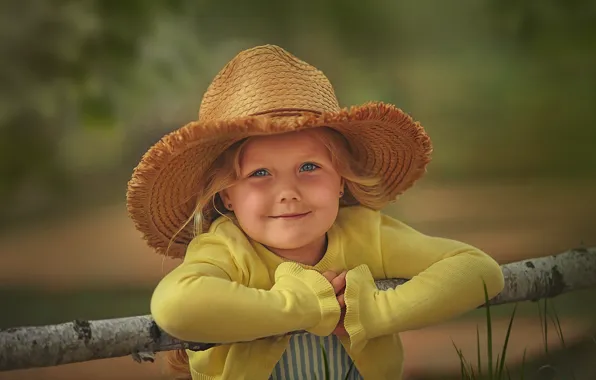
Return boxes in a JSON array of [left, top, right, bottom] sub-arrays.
[[127, 45, 432, 257]]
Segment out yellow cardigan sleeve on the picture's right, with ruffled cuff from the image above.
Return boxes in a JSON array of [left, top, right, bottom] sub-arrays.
[[344, 215, 504, 351]]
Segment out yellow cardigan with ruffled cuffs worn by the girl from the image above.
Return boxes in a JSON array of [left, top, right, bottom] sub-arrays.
[[151, 206, 504, 380]]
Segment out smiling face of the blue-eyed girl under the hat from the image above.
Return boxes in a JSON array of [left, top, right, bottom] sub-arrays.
[[220, 130, 343, 253]]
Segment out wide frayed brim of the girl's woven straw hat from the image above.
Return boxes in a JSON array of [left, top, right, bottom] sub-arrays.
[[127, 102, 432, 257]]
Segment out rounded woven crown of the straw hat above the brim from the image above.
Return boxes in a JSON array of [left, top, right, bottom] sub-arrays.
[[199, 45, 339, 122]]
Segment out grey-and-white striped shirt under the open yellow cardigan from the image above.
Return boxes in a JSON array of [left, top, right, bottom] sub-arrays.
[[269, 332, 363, 380]]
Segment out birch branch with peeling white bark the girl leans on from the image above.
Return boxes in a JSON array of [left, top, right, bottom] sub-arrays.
[[0, 247, 596, 371]]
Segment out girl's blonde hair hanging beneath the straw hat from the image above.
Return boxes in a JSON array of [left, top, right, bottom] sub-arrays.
[[165, 127, 384, 380]]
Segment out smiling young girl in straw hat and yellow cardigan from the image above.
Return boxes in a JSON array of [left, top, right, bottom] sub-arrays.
[[127, 45, 503, 380]]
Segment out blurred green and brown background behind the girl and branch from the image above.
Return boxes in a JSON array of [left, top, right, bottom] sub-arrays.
[[0, 0, 596, 380]]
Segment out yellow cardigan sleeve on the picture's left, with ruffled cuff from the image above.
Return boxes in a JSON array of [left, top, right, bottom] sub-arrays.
[[151, 234, 340, 343]]
